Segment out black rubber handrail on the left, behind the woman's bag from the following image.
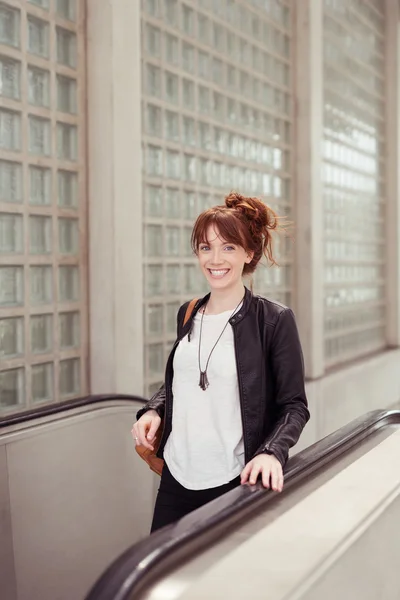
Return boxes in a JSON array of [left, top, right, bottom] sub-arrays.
[[0, 394, 147, 429]]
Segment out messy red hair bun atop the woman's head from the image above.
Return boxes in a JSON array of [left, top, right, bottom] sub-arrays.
[[225, 192, 278, 235]]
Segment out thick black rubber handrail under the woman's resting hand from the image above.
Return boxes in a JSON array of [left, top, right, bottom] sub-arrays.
[[85, 410, 400, 600]]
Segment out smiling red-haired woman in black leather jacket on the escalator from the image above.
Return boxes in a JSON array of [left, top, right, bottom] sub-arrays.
[[133, 193, 309, 531]]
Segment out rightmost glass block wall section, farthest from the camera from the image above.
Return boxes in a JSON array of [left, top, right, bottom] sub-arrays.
[[323, 0, 385, 366]]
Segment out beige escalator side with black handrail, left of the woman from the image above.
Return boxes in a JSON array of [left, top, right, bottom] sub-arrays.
[[0, 395, 157, 600]]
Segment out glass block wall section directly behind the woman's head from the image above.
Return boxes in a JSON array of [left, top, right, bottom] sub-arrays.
[[142, 0, 292, 393]]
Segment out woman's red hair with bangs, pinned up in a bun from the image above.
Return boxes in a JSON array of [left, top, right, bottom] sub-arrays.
[[191, 192, 281, 275]]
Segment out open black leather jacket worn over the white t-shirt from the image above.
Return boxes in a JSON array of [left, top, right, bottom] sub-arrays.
[[137, 288, 310, 465]]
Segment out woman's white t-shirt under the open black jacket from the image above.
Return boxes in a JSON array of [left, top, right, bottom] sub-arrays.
[[164, 311, 244, 490]]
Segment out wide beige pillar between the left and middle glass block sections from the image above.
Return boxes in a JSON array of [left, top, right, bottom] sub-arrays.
[[87, 0, 143, 394]]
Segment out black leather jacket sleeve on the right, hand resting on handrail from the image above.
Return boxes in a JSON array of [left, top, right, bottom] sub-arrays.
[[256, 308, 310, 466]]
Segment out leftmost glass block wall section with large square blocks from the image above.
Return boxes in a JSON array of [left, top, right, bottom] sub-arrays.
[[0, 0, 87, 414]]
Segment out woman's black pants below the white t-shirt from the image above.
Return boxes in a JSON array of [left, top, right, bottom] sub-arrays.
[[151, 464, 240, 533]]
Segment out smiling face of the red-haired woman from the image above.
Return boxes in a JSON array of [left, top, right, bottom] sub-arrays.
[[197, 225, 252, 290]]
